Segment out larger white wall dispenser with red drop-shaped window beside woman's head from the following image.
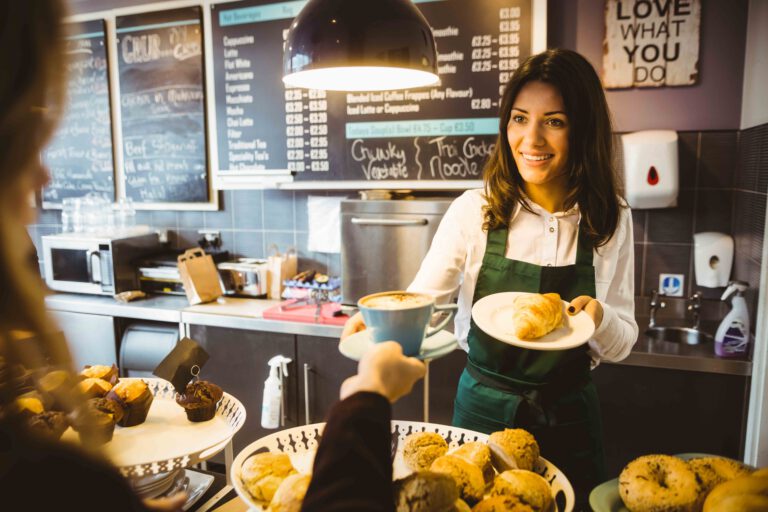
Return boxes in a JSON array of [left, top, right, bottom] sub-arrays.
[[621, 130, 680, 209]]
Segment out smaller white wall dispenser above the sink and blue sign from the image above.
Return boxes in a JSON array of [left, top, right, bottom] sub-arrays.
[[693, 231, 733, 288]]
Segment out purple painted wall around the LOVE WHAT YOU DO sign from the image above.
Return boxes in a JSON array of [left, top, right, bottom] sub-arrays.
[[547, 0, 747, 132]]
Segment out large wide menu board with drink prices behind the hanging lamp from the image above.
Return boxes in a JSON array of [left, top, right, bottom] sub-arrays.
[[211, 0, 532, 182]]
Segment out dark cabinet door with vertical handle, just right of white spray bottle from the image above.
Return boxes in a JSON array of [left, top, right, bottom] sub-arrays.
[[296, 336, 357, 425]]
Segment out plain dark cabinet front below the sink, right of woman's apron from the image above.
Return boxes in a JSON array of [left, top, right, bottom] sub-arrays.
[[592, 363, 749, 478]]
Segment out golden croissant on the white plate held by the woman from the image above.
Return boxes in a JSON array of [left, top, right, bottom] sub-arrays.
[[512, 293, 563, 340]]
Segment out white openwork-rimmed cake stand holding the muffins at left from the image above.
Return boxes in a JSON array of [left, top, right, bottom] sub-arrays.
[[64, 378, 245, 482]]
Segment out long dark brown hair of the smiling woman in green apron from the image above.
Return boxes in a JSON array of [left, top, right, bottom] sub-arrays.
[[483, 49, 621, 247]]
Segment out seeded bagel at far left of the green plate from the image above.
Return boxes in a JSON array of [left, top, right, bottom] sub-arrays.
[[619, 455, 699, 512]]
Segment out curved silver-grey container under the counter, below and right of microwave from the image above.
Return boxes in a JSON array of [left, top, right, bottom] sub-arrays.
[[118, 322, 179, 377]]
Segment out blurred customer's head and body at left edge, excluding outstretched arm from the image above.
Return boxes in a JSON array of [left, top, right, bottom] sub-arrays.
[[0, 0, 186, 511]]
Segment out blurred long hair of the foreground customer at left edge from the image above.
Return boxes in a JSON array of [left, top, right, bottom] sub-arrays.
[[0, 0, 70, 407]]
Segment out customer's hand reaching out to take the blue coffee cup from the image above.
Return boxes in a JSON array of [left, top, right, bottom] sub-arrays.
[[341, 341, 426, 403]]
